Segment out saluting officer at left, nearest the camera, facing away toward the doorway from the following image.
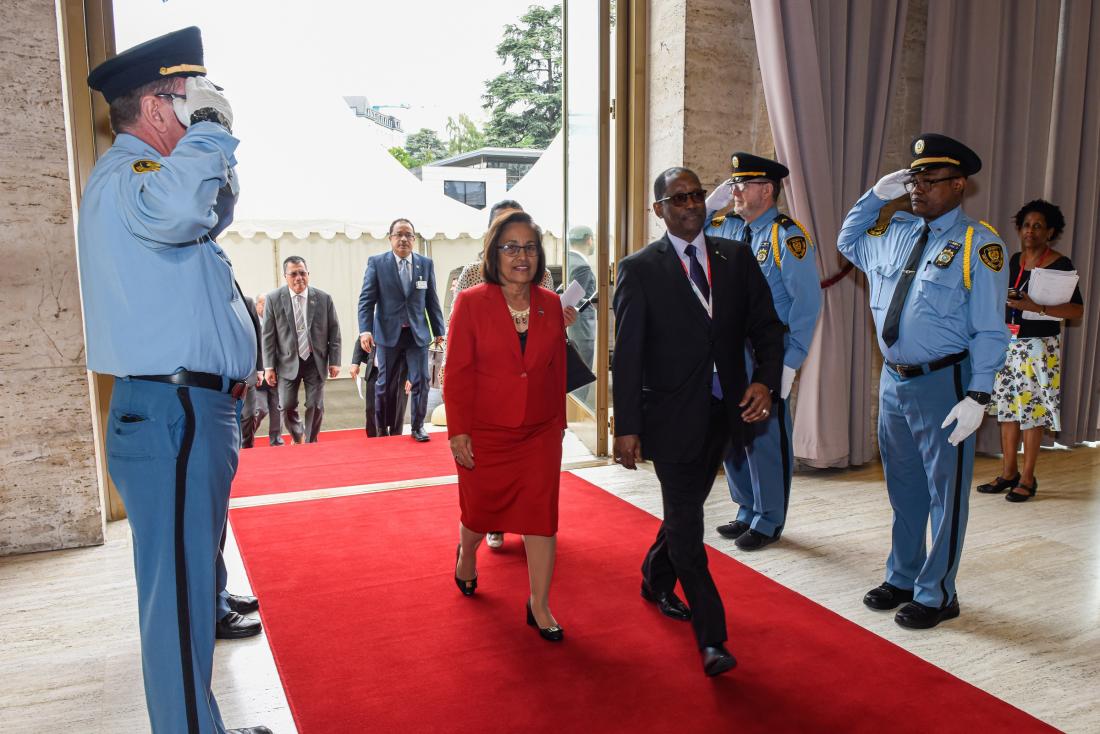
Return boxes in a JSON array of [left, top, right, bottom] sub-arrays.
[[78, 28, 268, 734]]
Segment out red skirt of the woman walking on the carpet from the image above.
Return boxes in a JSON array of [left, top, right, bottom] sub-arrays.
[[458, 420, 562, 536]]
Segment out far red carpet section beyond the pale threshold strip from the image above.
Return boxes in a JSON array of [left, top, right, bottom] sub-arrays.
[[231, 430, 455, 497]]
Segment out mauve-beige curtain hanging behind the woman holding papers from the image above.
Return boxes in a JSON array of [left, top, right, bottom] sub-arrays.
[[922, 0, 1100, 452]]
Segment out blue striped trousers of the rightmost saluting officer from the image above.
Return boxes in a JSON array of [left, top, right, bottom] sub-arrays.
[[879, 361, 977, 609]]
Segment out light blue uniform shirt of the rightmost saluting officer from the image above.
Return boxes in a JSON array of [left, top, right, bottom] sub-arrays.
[[837, 191, 1009, 393]]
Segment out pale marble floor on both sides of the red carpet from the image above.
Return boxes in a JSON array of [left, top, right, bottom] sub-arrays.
[[0, 446, 1100, 734]]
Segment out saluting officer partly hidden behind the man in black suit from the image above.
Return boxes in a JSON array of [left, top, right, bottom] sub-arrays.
[[706, 153, 822, 550]]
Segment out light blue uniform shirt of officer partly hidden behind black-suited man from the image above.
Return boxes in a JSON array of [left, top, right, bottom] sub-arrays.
[[706, 207, 822, 370]]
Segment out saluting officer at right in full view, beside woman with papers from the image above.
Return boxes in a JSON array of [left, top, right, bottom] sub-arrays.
[[837, 133, 1009, 629]]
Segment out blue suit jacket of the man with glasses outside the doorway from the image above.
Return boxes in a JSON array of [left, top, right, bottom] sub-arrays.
[[359, 251, 447, 347]]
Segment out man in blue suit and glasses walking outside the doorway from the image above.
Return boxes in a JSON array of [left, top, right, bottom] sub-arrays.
[[359, 219, 444, 441]]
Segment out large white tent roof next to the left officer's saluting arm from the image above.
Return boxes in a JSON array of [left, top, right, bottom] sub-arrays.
[[231, 80, 485, 239]]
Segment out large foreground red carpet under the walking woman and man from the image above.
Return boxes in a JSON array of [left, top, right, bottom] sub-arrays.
[[231, 474, 1055, 734]]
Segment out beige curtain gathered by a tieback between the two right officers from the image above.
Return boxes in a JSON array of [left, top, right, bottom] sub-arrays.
[[751, 0, 906, 468]]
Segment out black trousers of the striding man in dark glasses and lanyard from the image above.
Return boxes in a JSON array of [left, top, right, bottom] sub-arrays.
[[641, 399, 729, 648]]
